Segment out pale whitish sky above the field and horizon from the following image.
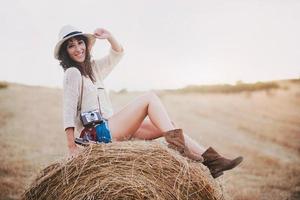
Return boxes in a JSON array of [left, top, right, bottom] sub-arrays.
[[0, 0, 300, 90]]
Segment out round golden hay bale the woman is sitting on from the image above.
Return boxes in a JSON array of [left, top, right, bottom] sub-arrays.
[[23, 141, 224, 200]]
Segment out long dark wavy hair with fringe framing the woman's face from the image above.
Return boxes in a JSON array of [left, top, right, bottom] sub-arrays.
[[58, 35, 96, 82]]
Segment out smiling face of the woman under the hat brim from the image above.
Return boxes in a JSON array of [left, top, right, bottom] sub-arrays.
[[67, 38, 86, 63]]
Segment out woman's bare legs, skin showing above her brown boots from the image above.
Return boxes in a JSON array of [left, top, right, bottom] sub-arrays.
[[108, 92, 204, 155]]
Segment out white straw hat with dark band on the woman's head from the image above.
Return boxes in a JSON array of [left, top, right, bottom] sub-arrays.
[[54, 25, 96, 59]]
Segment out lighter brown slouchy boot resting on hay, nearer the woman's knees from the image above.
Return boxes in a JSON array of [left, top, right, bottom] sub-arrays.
[[163, 129, 203, 162]]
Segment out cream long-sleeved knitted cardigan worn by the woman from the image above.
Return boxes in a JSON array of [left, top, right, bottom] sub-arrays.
[[63, 49, 124, 133]]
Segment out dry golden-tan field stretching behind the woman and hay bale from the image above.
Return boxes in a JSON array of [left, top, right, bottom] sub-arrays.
[[0, 81, 300, 200]]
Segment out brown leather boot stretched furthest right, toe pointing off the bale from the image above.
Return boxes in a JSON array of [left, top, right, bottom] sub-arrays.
[[202, 147, 243, 178]]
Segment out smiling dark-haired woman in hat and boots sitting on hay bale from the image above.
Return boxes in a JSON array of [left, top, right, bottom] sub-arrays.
[[54, 25, 242, 178]]
